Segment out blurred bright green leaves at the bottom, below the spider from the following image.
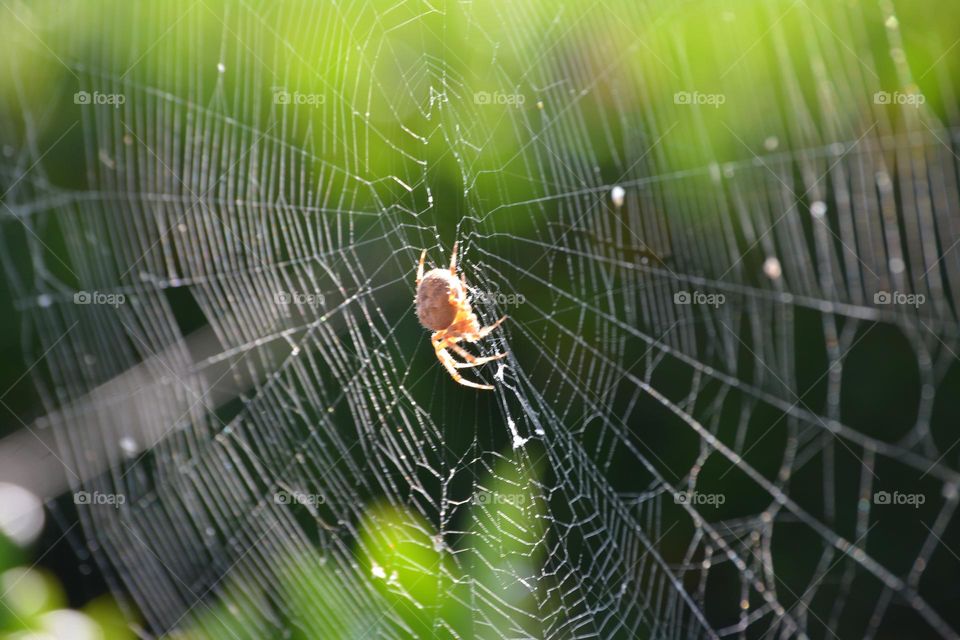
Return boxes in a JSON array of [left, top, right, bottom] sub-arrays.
[[177, 450, 549, 640]]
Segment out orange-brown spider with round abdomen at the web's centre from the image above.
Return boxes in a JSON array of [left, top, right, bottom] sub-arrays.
[[415, 242, 507, 389]]
